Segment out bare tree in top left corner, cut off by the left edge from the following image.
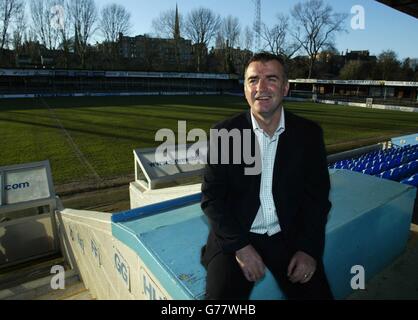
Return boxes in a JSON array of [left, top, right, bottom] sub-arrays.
[[0, 0, 24, 50]]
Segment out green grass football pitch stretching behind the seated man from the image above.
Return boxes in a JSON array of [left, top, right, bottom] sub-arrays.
[[0, 96, 418, 185]]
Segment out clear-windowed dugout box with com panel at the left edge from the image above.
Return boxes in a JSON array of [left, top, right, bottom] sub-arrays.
[[0, 160, 59, 269]]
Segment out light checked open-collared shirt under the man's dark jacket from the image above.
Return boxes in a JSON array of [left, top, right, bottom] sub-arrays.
[[250, 107, 285, 236]]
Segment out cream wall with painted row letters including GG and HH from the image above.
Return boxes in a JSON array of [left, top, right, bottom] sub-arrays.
[[57, 209, 171, 300]]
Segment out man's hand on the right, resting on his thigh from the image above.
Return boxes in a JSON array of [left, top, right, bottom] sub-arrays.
[[287, 251, 316, 283]]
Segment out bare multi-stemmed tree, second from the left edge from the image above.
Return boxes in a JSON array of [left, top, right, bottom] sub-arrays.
[[30, 0, 60, 50]]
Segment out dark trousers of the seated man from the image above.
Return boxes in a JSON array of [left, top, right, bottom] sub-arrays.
[[206, 233, 333, 300]]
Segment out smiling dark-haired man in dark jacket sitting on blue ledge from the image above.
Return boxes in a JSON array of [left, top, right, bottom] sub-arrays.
[[201, 53, 332, 299]]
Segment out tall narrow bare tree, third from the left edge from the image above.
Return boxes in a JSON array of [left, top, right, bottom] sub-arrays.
[[68, 0, 97, 67]]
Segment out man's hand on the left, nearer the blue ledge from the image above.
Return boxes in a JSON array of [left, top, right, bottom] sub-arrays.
[[235, 244, 266, 282]]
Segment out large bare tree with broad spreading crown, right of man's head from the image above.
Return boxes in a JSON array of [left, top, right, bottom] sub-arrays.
[[291, 0, 347, 78]]
